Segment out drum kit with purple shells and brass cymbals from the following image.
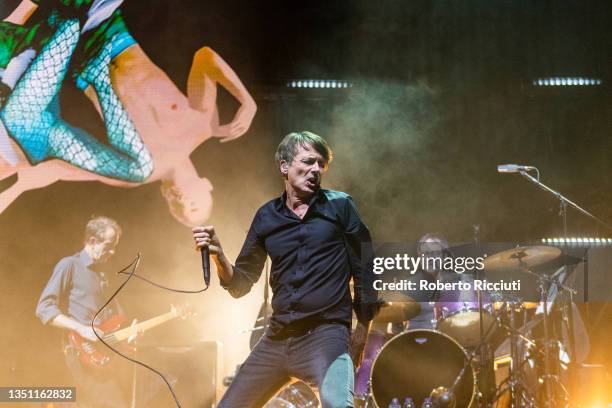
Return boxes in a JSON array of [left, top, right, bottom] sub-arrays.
[[355, 246, 574, 408]]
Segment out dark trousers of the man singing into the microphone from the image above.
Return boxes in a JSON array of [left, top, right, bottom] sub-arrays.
[[218, 324, 354, 408]]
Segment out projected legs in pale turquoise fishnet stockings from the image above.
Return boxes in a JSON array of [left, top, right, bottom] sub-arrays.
[[1, 19, 153, 182]]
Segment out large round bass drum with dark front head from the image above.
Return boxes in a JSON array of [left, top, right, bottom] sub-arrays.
[[372, 330, 476, 408]]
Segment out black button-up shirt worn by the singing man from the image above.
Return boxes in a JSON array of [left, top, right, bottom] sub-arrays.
[[221, 189, 376, 336]]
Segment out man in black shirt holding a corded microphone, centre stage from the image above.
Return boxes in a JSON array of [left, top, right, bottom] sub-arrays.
[[193, 131, 377, 408]]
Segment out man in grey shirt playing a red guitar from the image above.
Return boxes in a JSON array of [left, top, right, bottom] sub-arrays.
[[36, 216, 133, 408]]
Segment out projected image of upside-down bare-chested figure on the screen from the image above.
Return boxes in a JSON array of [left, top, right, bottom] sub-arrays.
[[0, 0, 256, 225]]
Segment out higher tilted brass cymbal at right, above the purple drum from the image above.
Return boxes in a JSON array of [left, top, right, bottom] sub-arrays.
[[484, 245, 561, 271]]
